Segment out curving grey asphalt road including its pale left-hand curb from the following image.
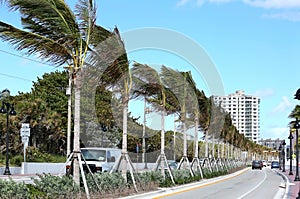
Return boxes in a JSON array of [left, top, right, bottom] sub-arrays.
[[123, 167, 285, 199]]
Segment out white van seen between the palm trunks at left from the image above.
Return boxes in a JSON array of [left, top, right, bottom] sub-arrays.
[[67, 147, 121, 173]]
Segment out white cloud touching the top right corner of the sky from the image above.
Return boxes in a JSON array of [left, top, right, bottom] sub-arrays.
[[243, 0, 300, 9]]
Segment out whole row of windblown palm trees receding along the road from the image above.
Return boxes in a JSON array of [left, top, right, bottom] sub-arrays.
[[0, 0, 270, 187]]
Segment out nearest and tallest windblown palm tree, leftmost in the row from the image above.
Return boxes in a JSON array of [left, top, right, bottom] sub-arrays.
[[0, 0, 112, 184]]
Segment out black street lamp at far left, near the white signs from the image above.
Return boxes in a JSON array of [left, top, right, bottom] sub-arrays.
[[0, 102, 17, 175]]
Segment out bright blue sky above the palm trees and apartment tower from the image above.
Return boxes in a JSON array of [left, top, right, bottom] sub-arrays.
[[0, 0, 300, 139]]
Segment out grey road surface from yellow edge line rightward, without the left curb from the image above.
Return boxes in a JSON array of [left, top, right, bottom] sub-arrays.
[[152, 168, 283, 199]]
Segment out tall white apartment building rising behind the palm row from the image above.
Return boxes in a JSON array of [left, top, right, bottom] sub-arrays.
[[213, 90, 260, 143]]
